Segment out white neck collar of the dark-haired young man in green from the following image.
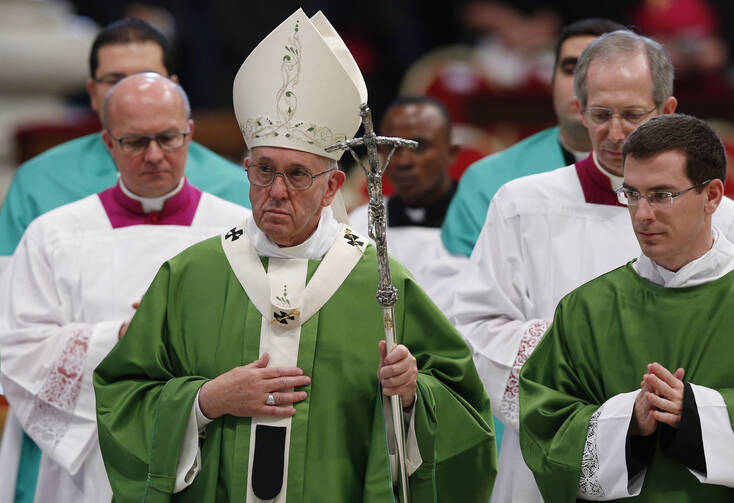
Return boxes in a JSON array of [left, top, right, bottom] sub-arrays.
[[634, 227, 734, 288]]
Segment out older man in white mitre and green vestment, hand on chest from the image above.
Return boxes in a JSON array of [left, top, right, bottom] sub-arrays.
[[95, 9, 496, 503]]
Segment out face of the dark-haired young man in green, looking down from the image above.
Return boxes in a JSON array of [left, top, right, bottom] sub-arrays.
[[624, 151, 723, 271]]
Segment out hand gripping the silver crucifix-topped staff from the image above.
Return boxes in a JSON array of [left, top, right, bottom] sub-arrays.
[[377, 341, 418, 407]]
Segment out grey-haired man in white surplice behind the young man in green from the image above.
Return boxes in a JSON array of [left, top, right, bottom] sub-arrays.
[[450, 30, 734, 502]]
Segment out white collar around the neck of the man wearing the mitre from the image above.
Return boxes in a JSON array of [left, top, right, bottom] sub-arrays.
[[245, 206, 339, 260]]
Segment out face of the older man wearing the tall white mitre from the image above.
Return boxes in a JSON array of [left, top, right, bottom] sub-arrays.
[[249, 147, 345, 246]]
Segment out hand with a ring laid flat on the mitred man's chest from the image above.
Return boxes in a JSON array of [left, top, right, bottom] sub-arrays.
[[199, 353, 311, 419]]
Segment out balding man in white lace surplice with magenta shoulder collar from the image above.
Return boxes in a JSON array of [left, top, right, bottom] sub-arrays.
[[0, 73, 249, 503]]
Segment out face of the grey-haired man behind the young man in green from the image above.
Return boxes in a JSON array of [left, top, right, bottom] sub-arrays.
[[576, 53, 676, 176]]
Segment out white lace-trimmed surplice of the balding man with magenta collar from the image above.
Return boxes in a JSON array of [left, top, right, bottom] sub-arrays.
[[0, 193, 249, 503]]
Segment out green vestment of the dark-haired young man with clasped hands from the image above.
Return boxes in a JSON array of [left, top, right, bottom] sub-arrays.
[[520, 262, 734, 503]]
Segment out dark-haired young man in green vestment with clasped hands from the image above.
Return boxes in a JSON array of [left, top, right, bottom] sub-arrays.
[[520, 114, 734, 503]]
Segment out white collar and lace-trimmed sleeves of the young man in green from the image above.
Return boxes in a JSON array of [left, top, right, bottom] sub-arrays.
[[579, 228, 734, 501]]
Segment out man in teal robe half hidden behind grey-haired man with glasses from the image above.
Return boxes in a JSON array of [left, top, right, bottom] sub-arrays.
[[426, 19, 623, 310]]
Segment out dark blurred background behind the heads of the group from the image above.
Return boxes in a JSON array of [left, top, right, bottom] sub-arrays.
[[0, 0, 734, 206]]
